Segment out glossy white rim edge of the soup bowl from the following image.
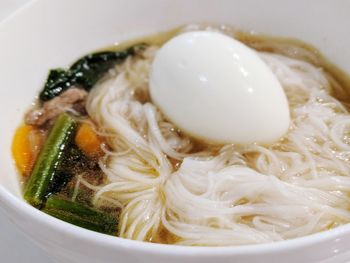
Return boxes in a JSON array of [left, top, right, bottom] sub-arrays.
[[0, 0, 350, 256]]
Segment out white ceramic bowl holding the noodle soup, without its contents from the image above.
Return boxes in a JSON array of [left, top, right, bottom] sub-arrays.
[[0, 0, 350, 263]]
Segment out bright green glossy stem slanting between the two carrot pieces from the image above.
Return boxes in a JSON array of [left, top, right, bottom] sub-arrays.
[[24, 114, 77, 207]]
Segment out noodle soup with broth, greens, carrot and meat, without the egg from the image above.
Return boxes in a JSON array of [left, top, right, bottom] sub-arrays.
[[13, 25, 350, 246]]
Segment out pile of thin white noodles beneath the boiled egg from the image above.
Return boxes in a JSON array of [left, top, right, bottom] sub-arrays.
[[87, 27, 350, 246]]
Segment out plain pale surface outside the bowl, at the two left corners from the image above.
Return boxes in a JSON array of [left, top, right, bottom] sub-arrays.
[[0, 0, 53, 263]]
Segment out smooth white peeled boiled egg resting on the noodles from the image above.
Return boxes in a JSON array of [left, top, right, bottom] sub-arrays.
[[150, 31, 290, 144]]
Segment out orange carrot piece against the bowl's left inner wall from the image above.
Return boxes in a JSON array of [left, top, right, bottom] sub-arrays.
[[12, 124, 43, 176]]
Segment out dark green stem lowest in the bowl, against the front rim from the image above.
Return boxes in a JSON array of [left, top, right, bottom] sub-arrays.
[[43, 195, 118, 235]]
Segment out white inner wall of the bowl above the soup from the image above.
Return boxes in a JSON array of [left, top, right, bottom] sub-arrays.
[[0, 0, 350, 254]]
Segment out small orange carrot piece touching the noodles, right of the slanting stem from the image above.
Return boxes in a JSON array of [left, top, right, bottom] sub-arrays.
[[75, 123, 103, 157]]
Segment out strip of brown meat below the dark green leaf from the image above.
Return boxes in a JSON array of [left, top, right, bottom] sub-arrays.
[[25, 87, 88, 126]]
